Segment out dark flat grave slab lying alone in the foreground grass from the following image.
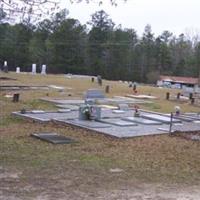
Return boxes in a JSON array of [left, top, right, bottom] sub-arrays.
[[31, 133, 75, 144]]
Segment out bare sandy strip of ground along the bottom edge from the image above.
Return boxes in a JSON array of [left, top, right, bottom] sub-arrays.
[[0, 167, 200, 200]]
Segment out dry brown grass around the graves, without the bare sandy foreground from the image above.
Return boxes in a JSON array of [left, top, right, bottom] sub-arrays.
[[0, 73, 200, 196]]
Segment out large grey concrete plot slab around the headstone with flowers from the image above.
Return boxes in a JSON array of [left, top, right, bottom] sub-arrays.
[[13, 110, 200, 138]]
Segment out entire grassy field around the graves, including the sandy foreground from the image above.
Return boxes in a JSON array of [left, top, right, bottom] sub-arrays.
[[0, 73, 200, 200]]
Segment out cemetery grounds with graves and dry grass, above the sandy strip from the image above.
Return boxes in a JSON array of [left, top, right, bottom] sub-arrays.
[[0, 71, 200, 198]]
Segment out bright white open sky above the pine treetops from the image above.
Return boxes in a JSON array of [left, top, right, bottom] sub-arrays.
[[61, 0, 200, 36]]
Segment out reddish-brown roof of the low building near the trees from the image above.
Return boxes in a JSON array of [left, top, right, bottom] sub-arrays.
[[160, 76, 198, 85]]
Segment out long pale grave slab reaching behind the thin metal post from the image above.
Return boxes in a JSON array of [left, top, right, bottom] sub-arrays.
[[141, 112, 181, 124]]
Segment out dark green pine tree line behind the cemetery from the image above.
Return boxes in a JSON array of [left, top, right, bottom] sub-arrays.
[[0, 10, 200, 83]]
